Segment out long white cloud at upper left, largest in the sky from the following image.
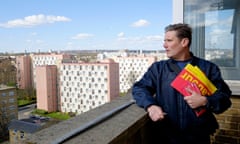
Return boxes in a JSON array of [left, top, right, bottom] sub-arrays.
[[0, 14, 71, 28]]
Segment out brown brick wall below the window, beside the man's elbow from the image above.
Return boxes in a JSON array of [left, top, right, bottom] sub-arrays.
[[212, 96, 240, 144]]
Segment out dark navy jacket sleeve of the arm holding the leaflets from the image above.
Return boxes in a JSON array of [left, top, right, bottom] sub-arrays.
[[207, 66, 232, 114]]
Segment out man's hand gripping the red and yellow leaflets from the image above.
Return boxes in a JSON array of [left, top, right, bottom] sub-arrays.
[[184, 88, 207, 109]]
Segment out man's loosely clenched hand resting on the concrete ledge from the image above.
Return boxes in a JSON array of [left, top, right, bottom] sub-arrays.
[[147, 105, 166, 121]]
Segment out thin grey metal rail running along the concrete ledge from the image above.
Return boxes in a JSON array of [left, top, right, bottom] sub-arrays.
[[51, 100, 135, 144]]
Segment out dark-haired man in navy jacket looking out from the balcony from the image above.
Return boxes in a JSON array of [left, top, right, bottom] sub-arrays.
[[132, 24, 231, 144]]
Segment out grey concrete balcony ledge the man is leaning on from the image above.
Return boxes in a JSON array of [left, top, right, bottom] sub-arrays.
[[26, 94, 146, 144]]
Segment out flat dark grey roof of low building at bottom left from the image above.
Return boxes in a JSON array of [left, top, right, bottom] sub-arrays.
[[8, 120, 41, 133]]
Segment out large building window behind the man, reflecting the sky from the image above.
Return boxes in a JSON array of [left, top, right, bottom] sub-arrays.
[[183, 0, 240, 80]]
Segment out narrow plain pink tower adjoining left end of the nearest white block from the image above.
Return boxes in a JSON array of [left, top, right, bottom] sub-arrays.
[[36, 65, 58, 112]]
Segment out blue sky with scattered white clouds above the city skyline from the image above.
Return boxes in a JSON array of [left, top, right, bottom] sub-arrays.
[[0, 0, 172, 53]]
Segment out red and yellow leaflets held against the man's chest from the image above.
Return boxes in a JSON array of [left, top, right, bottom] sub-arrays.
[[171, 64, 217, 116]]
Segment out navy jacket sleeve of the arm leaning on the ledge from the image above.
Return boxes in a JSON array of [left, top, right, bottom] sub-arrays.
[[132, 64, 157, 110]]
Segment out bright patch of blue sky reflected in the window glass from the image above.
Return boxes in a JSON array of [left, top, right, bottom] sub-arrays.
[[205, 9, 234, 49]]
